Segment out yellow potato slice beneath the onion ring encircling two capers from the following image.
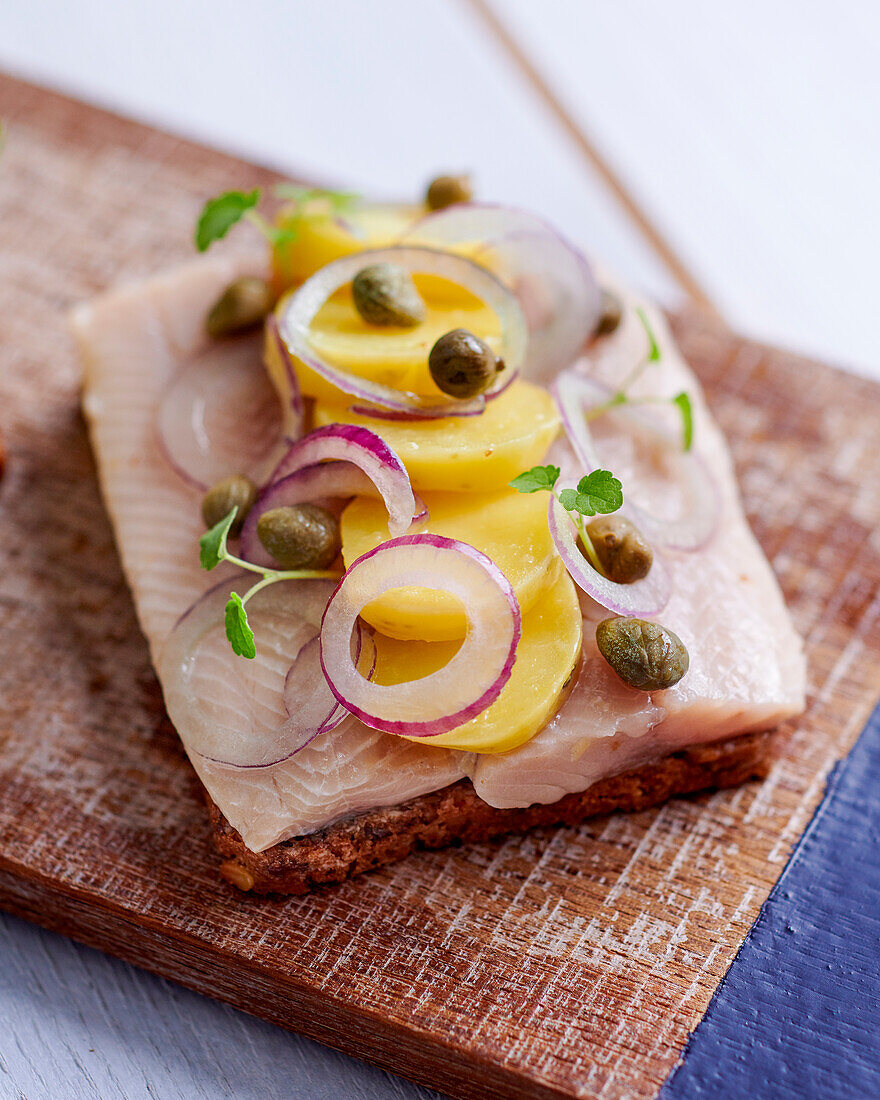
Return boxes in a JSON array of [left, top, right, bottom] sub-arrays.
[[277, 275, 501, 403]]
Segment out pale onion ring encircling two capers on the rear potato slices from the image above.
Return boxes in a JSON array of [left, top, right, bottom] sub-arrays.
[[278, 248, 526, 419]]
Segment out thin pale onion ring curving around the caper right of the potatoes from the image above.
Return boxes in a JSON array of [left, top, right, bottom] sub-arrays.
[[547, 496, 672, 616]]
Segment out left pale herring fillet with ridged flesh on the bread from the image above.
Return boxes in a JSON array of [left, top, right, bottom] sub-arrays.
[[73, 256, 464, 851]]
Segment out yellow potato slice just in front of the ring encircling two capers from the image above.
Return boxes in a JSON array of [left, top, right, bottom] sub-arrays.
[[314, 380, 559, 493]]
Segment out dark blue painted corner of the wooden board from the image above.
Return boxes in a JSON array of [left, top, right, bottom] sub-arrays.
[[659, 706, 880, 1100]]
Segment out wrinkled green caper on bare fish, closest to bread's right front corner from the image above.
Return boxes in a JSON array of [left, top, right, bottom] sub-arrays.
[[596, 616, 690, 691]]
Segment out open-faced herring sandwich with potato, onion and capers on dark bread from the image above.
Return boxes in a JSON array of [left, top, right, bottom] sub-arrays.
[[75, 177, 805, 893]]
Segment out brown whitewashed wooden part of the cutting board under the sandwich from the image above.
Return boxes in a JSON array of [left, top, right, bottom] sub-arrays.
[[0, 77, 880, 1098]]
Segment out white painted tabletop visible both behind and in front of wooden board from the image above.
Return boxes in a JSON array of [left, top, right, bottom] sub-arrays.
[[0, 0, 880, 1100]]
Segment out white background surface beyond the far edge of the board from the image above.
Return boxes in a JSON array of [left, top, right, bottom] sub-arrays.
[[0, 0, 880, 373]]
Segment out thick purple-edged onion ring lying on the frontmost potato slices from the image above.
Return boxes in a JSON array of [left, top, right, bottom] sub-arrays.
[[321, 534, 523, 737]]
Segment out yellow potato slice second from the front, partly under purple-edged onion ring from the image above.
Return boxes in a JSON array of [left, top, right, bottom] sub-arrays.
[[341, 488, 559, 641]]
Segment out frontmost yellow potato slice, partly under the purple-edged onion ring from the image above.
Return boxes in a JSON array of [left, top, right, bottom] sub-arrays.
[[374, 563, 583, 752]]
